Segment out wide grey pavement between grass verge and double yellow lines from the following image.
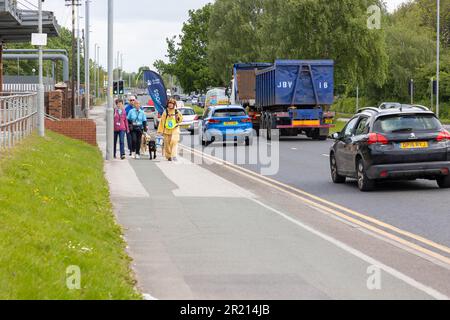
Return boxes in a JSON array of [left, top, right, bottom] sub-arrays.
[[91, 108, 450, 300]]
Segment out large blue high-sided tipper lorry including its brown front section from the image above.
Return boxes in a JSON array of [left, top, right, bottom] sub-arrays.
[[231, 60, 334, 140]]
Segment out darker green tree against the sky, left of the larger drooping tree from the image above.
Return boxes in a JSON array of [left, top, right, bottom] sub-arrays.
[[154, 4, 217, 92]]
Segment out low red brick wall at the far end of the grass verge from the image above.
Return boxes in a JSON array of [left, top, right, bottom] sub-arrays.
[[45, 119, 97, 146]]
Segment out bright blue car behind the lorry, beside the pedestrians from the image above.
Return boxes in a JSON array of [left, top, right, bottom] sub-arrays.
[[200, 105, 253, 146]]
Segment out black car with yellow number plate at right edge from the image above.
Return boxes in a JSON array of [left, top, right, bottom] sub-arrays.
[[330, 104, 450, 191]]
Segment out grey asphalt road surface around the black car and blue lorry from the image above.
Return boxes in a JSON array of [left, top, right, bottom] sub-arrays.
[[182, 132, 450, 246]]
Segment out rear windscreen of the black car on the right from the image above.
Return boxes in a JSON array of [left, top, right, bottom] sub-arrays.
[[374, 114, 442, 133]]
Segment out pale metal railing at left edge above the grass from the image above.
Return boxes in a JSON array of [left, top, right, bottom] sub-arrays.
[[0, 93, 37, 152]]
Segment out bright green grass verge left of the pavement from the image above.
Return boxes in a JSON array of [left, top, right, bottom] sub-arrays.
[[0, 132, 141, 300]]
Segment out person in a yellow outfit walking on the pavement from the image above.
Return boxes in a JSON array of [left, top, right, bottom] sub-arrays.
[[158, 99, 183, 161]]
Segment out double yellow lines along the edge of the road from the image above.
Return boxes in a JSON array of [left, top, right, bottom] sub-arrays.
[[181, 145, 450, 266]]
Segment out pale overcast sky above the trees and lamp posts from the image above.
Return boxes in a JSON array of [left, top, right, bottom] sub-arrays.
[[37, 0, 407, 71]]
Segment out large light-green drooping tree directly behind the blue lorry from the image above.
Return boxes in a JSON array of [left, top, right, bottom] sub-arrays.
[[208, 0, 388, 87]]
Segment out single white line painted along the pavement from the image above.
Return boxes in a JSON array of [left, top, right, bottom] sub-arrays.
[[251, 199, 449, 300]]
